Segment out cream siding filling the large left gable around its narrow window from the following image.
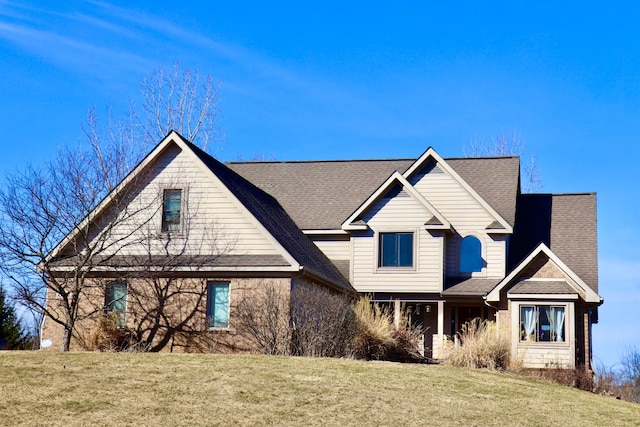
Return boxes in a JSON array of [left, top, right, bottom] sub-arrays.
[[84, 145, 279, 255]]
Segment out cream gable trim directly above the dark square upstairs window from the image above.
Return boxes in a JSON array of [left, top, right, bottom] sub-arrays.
[[341, 172, 451, 230]]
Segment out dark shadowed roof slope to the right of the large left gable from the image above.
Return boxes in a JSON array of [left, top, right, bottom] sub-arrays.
[[185, 140, 356, 293]]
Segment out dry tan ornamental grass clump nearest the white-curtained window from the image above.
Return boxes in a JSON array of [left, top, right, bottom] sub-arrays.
[[444, 318, 510, 370]]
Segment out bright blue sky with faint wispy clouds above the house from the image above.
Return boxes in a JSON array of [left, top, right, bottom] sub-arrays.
[[0, 0, 640, 365]]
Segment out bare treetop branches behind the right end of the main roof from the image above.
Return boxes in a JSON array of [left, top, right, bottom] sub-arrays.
[[462, 130, 542, 193]]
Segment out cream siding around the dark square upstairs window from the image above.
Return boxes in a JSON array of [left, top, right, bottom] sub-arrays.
[[352, 192, 443, 292]]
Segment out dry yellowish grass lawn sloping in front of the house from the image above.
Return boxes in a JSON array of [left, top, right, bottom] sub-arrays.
[[0, 352, 640, 427]]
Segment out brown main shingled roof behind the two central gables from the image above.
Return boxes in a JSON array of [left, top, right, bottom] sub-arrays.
[[227, 157, 520, 230]]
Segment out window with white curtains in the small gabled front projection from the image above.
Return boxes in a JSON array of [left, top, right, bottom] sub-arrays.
[[520, 305, 565, 342]]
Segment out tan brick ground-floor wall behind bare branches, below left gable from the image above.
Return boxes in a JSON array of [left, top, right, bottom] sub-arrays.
[[42, 278, 291, 353]]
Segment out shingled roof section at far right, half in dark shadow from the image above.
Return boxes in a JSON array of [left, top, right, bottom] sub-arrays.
[[508, 193, 598, 292]]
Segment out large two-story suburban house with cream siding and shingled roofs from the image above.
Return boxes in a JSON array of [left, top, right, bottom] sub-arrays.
[[43, 132, 603, 368]]
